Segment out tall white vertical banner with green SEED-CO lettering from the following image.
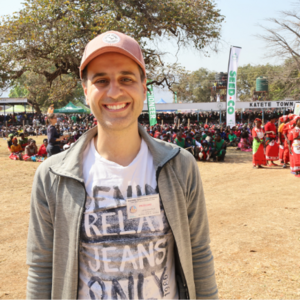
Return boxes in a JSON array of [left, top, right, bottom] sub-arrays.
[[226, 46, 242, 128]]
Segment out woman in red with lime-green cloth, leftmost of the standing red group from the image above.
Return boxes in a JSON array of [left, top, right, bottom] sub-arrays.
[[252, 119, 267, 169]]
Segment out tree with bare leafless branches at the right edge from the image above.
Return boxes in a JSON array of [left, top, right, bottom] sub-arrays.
[[259, 0, 300, 99]]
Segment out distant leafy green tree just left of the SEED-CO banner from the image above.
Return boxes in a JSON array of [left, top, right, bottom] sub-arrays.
[[174, 68, 215, 102]]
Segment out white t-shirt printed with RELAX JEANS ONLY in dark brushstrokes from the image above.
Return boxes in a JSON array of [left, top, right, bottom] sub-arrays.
[[78, 140, 178, 299]]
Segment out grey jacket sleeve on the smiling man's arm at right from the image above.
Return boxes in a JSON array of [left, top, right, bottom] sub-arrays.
[[186, 160, 218, 299]]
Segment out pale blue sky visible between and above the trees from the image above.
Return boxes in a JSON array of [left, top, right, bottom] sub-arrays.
[[0, 0, 295, 102]]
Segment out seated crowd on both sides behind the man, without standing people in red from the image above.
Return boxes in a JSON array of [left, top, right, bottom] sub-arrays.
[[7, 119, 253, 161]]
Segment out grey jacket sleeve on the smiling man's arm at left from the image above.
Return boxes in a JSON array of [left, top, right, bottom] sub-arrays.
[[27, 165, 53, 299]]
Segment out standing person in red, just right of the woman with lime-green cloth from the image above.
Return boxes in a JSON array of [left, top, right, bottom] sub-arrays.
[[265, 115, 279, 166]]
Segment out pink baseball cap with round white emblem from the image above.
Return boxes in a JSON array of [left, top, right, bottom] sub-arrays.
[[79, 31, 146, 79]]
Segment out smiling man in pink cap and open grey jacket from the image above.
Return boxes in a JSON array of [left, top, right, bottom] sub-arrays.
[[27, 31, 217, 299]]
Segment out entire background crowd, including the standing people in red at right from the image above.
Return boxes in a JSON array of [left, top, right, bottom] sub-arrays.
[[2, 113, 300, 177]]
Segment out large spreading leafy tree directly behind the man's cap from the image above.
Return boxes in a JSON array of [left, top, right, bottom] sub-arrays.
[[0, 0, 224, 110]]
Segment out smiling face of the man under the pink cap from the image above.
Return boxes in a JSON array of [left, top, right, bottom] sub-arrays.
[[83, 53, 147, 131]]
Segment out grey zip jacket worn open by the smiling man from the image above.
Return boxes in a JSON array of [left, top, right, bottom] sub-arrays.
[[27, 125, 218, 299]]
